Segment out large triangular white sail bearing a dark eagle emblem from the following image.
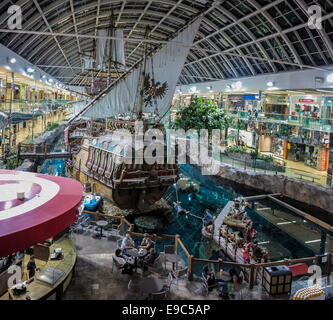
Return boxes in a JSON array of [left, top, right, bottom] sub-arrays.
[[81, 18, 201, 119]]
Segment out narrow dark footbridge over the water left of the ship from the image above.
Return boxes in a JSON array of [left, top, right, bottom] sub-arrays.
[[17, 144, 72, 160]]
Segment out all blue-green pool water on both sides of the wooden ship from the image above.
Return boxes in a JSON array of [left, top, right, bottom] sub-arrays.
[[41, 139, 330, 275]]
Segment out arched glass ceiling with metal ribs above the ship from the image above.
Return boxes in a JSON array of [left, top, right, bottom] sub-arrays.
[[0, 0, 333, 89]]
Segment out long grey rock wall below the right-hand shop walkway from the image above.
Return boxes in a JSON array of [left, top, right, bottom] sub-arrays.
[[213, 164, 333, 213]]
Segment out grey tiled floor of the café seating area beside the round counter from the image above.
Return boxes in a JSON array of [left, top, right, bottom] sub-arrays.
[[64, 234, 330, 300]]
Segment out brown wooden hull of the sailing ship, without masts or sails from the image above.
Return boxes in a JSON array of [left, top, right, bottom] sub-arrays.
[[66, 121, 179, 209]]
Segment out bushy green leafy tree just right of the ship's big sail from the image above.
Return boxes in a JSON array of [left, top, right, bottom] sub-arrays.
[[172, 96, 228, 133]]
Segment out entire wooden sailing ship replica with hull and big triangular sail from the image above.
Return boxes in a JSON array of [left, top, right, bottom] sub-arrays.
[[65, 18, 201, 210]]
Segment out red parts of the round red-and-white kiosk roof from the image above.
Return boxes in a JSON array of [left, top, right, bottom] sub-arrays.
[[0, 170, 83, 257]]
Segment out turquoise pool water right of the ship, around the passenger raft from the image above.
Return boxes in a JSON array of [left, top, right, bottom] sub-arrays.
[[159, 165, 332, 273]]
